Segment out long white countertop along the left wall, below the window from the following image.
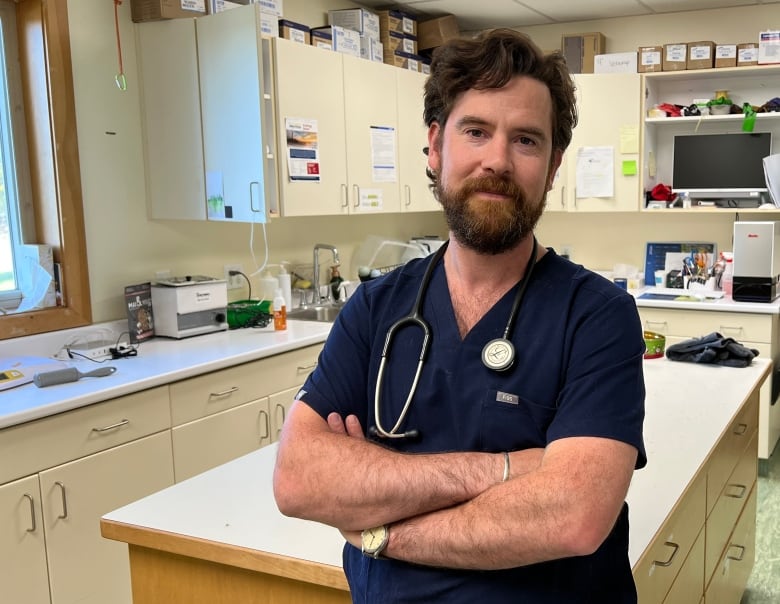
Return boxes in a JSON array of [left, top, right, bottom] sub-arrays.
[[0, 321, 331, 428]]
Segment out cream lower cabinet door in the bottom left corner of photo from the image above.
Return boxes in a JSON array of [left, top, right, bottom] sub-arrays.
[[0, 475, 49, 604]]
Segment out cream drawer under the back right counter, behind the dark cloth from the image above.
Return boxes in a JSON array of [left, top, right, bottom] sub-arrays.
[[639, 307, 776, 343]]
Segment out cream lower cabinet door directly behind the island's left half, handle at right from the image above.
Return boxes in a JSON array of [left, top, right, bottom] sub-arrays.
[[172, 398, 271, 482]]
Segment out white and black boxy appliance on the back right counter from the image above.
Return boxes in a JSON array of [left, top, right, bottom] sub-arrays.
[[732, 221, 780, 302]]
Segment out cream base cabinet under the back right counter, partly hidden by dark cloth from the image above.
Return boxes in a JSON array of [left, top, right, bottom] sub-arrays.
[[639, 306, 780, 459]]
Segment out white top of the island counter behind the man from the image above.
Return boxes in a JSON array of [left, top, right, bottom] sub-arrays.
[[104, 358, 770, 567]]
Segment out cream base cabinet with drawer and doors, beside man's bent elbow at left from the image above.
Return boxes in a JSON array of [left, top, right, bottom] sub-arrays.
[[170, 344, 322, 482]]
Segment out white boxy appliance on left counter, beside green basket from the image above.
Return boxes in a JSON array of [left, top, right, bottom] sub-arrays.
[[152, 275, 228, 338]]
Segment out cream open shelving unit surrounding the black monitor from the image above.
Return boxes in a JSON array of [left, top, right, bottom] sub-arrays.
[[642, 65, 780, 212]]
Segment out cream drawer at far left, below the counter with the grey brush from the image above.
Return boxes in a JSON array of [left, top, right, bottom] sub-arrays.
[[0, 386, 171, 484]]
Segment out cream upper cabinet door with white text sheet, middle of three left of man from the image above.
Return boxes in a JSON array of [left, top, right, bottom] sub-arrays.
[[342, 55, 401, 214]]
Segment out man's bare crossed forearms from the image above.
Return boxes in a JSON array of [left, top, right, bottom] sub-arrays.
[[274, 401, 637, 569]]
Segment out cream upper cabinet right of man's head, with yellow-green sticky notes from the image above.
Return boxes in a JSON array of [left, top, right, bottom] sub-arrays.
[[547, 73, 642, 212]]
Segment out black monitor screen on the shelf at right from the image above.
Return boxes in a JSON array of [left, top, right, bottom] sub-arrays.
[[672, 132, 772, 192]]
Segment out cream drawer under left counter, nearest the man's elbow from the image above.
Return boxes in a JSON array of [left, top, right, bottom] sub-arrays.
[[170, 344, 322, 426]]
